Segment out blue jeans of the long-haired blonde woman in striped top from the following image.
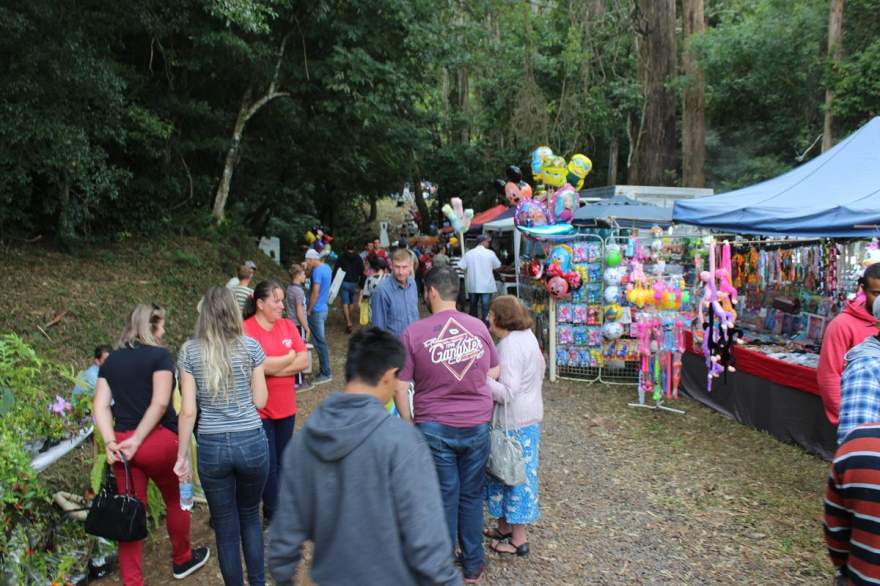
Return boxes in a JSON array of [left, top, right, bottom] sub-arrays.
[[198, 429, 269, 586]]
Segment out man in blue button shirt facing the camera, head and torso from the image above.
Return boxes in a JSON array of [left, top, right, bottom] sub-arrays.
[[370, 248, 419, 338]]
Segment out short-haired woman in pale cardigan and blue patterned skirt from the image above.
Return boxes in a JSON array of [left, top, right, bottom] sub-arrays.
[[484, 295, 546, 557]]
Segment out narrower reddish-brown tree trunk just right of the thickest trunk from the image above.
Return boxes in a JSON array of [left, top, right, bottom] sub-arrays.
[[681, 0, 706, 187]]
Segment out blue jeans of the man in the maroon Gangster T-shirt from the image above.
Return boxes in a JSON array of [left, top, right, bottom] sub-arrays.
[[417, 422, 489, 574]]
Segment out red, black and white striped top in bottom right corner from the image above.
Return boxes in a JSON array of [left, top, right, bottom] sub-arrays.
[[823, 423, 880, 584]]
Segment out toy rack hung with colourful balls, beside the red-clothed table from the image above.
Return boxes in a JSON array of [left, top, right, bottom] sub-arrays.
[[600, 231, 701, 394]]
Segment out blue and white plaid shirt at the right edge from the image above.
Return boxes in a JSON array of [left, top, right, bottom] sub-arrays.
[[837, 352, 880, 445]]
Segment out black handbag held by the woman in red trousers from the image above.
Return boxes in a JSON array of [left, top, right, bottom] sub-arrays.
[[86, 455, 147, 541]]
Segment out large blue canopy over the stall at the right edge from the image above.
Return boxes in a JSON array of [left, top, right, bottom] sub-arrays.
[[672, 117, 880, 238]]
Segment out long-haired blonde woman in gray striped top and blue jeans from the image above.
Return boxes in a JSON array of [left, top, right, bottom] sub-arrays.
[[174, 287, 269, 585]]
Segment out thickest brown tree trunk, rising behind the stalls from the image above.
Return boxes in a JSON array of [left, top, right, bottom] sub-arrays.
[[628, 0, 677, 185]]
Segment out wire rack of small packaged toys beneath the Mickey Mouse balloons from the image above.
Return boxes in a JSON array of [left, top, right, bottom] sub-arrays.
[[550, 234, 605, 381]]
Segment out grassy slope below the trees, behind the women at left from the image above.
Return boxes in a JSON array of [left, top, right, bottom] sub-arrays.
[[0, 238, 286, 367]]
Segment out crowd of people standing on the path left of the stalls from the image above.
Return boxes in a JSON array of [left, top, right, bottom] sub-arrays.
[[79, 234, 545, 585]]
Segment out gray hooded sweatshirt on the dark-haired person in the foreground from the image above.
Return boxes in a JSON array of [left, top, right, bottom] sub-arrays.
[[268, 393, 462, 586]]
